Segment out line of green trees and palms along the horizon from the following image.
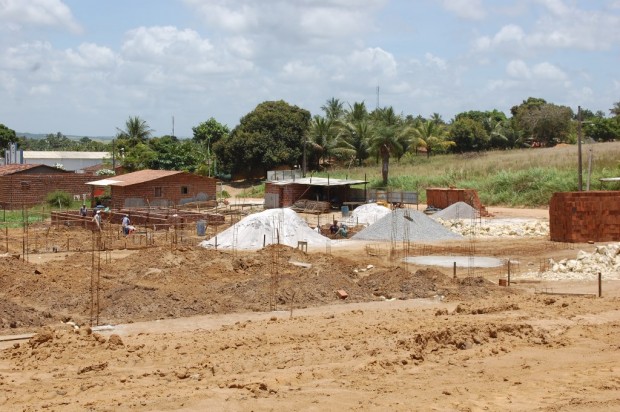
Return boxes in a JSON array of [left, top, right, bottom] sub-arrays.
[[0, 97, 620, 184]]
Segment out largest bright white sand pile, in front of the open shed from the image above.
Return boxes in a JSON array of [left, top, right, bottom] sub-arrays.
[[200, 209, 329, 250]]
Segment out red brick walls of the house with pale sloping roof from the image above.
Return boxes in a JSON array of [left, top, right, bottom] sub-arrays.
[[111, 173, 217, 209]]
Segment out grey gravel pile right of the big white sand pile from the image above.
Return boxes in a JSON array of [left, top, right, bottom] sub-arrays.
[[352, 209, 462, 241]]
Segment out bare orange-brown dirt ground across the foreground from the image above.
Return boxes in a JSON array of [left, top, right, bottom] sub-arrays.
[[0, 201, 620, 411]]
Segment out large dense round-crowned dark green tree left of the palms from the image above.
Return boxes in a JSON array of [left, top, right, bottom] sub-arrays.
[[213, 100, 310, 176]]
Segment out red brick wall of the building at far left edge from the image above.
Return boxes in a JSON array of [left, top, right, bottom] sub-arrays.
[[0, 173, 93, 209]]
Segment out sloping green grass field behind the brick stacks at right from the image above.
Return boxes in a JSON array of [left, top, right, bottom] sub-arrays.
[[315, 142, 620, 207]]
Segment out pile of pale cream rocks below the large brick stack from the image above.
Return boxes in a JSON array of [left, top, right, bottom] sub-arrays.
[[516, 243, 620, 280]]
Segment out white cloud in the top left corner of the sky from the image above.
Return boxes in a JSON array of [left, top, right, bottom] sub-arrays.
[[0, 0, 82, 33]]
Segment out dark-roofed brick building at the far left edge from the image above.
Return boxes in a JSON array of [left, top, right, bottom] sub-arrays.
[[0, 164, 93, 210]]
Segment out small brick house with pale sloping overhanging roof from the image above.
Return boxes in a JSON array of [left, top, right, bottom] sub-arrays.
[[87, 170, 217, 209]]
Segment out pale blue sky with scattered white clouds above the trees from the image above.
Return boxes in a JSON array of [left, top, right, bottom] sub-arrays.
[[0, 0, 620, 138]]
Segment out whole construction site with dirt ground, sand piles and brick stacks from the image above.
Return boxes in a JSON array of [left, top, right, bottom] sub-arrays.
[[0, 185, 620, 411]]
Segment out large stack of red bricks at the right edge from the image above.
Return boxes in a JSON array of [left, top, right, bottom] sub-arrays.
[[549, 191, 620, 243]]
